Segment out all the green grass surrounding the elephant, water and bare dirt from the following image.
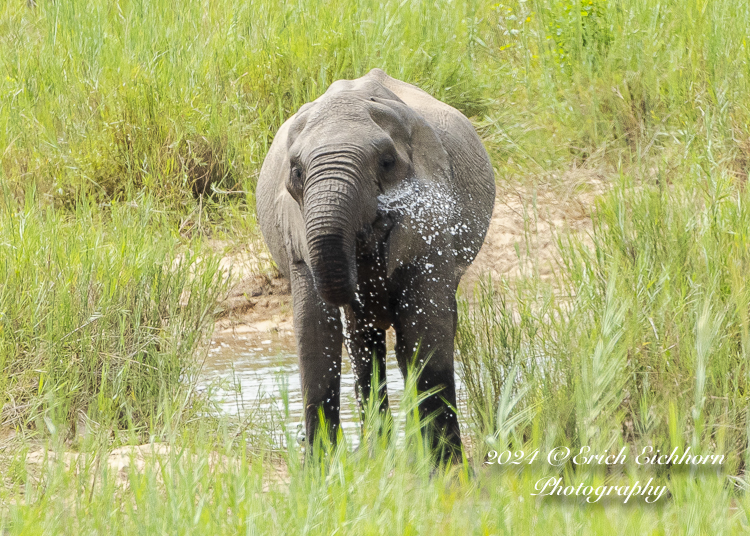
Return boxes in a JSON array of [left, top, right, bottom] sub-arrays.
[[0, 0, 750, 534]]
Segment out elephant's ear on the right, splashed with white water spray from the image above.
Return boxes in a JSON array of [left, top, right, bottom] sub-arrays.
[[385, 104, 454, 277]]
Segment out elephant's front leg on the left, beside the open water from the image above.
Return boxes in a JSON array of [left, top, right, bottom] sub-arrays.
[[290, 263, 342, 452]]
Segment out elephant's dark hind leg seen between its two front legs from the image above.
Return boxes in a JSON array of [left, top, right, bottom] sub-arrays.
[[346, 308, 388, 426]]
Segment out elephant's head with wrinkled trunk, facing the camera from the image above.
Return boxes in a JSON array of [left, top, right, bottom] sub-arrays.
[[287, 80, 450, 305]]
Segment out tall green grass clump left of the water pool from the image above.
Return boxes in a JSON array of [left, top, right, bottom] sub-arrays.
[[0, 186, 224, 433]]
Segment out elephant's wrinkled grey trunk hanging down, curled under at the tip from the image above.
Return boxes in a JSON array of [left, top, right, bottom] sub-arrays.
[[304, 149, 359, 306]]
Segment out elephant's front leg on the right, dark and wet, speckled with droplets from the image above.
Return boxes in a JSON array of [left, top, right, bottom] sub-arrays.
[[395, 269, 461, 462]]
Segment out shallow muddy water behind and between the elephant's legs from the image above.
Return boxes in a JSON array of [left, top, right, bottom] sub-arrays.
[[198, 332, 463, 444]]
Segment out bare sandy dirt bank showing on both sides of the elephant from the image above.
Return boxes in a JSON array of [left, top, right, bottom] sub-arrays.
[[214, 169, 606, 337]]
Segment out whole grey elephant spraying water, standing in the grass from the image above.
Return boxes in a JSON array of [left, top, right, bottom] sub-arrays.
[[255, 69, 495, 461]]
